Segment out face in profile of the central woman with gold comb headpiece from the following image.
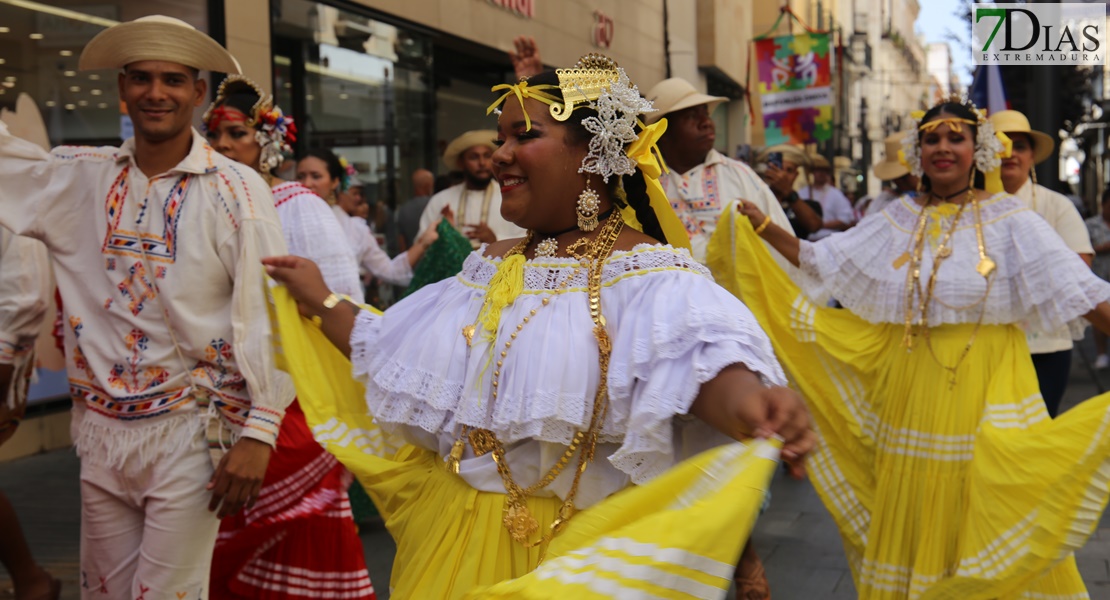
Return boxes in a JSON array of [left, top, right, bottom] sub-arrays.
[[493, 99, 607, 232]]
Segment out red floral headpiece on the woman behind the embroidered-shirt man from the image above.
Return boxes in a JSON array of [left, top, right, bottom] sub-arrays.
[[203, 75, 296, 173]]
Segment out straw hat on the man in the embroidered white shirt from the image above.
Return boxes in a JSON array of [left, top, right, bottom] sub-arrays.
[[77, 14, 240, 74]]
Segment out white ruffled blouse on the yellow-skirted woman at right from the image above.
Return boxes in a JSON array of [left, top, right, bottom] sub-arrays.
[[798, 194, 1110, 339]]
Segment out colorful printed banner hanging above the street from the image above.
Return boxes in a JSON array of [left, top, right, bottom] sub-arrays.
[[756, 33, 833, 145]]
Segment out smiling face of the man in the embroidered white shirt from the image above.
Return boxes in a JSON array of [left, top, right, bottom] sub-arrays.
[[119, 60, 208, 143]]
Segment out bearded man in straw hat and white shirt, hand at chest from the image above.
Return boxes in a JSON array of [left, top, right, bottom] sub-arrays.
[[416, 130, 525, 248]]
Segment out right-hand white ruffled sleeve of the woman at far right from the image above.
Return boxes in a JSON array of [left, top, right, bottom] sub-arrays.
[[999, 211, 1110, 339]]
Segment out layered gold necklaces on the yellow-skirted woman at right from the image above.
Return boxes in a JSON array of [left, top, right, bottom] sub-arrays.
[[894, 187, 996, 385]]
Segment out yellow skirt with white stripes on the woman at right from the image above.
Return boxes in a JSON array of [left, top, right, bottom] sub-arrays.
[[709, 206, 1110, 600]]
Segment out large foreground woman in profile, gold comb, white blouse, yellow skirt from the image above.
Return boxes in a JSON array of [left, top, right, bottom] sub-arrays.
[[264, 57, 811, 599]]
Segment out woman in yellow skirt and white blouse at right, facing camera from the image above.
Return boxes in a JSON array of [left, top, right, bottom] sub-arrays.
[[723, 95, 1110, 600]]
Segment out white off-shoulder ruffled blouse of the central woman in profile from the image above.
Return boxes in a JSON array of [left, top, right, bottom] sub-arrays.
[[351, 244, 785, 508]]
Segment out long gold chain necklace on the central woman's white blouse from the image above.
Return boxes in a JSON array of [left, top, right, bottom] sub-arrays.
[[447, 213, 624, 548]]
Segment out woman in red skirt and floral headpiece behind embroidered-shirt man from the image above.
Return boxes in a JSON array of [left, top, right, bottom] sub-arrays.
[[204, 75, 375, 600]]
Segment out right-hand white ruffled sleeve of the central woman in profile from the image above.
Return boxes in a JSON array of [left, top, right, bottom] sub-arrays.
[[603, 257, 786, 484]]
